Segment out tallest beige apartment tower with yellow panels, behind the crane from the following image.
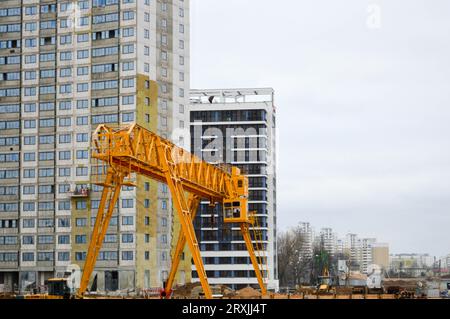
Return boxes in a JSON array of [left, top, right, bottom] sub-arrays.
[[0, 0, 191, 296]]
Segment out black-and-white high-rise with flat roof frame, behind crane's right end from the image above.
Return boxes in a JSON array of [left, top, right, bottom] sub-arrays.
[[190, 89, 278, 289]]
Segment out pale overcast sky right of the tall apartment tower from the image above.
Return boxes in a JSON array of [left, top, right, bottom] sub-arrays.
[[191, 0, 450, 256]]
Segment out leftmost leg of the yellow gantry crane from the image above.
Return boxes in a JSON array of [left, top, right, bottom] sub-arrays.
[[79, 168, 124, 296]]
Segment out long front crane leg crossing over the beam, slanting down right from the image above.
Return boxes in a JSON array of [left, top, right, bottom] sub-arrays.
[[156, 137, 212, 299]]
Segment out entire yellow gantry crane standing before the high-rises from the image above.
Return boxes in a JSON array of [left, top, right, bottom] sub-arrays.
[[78, 124, 267, 299]]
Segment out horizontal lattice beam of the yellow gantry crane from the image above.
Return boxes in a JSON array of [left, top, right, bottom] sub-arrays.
[[92, 124, 239, 201]]
